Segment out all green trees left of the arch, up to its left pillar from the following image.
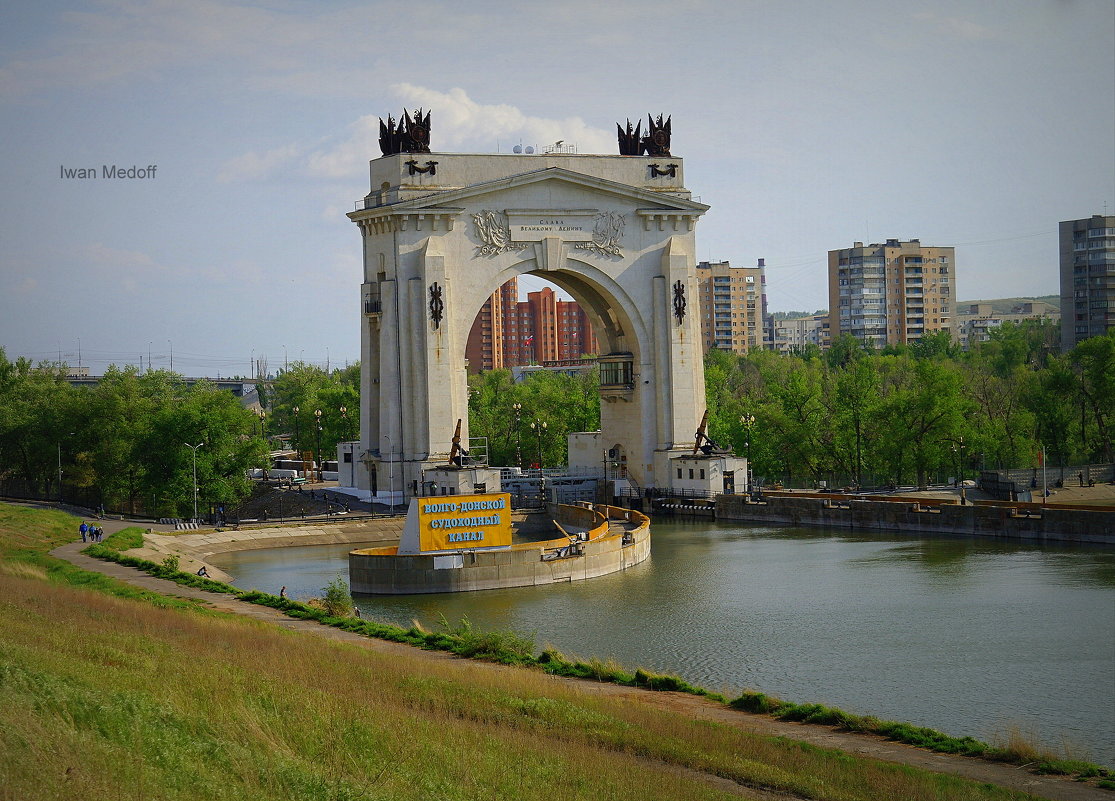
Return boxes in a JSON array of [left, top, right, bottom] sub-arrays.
[[0, 347, 360, 518]]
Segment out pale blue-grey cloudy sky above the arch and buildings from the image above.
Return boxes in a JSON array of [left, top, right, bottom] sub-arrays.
[[0, 0, 1115, 377]]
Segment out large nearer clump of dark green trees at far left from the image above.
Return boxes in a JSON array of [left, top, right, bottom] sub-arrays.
[[0, 348, 268, 517]]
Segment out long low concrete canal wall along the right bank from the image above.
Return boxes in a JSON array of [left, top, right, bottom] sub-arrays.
[[716, 495, 1115, 544]]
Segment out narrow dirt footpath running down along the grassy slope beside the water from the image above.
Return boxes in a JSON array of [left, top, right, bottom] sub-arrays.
[[51, 539, 1115, 801]]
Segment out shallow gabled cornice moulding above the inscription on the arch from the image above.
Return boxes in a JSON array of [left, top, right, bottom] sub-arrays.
[[381, 167, 709, 216]]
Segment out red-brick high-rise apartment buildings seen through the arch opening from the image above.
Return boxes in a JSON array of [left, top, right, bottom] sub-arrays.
[[465, 278, 599, 373]]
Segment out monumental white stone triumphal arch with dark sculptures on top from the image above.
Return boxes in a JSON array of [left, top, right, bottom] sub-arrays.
[[348, 112, 708, 499]]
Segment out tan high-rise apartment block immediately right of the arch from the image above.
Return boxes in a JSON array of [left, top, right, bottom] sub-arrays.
[[697, 259, 767, 354]]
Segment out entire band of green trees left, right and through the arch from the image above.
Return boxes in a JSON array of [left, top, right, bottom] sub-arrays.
[[0, 320, 1115, 517]]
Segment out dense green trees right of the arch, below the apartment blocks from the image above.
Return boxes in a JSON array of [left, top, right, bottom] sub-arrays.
[[706, 320, 1115, 485]]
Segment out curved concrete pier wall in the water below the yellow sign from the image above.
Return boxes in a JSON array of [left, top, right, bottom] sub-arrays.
[[349, 505, 650, 595]]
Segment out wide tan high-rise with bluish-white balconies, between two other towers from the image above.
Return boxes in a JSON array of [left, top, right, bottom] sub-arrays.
[[828, 239, 957, 346]]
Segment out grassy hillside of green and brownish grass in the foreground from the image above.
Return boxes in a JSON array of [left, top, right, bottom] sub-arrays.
[[0, 504, 1097, 801]]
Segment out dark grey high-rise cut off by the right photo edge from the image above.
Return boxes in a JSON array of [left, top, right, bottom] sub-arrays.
[[1060, 214, 1115, 350]]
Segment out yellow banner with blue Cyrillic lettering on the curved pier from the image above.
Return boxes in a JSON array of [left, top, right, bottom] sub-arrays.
[[417, 492, 511, 553]]
